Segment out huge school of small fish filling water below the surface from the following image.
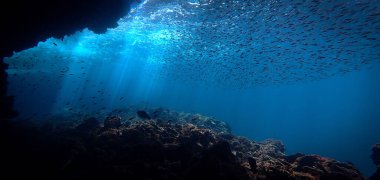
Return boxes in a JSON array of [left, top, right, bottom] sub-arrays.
[[5, 0, 380, 104]]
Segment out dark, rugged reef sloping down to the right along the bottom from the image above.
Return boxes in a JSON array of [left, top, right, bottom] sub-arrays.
[[2, 109, 364, 180]]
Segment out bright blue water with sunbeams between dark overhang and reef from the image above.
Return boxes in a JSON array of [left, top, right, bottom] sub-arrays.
[[5, 0, 380, 175]]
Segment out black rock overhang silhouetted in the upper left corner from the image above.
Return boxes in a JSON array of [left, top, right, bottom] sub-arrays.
[[0, 0, 139, 120]]
